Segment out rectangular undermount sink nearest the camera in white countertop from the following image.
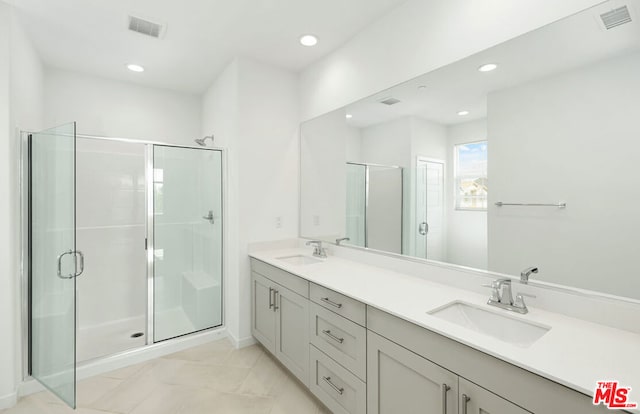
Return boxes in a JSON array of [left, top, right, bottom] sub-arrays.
[[427, 301, 551, 347]]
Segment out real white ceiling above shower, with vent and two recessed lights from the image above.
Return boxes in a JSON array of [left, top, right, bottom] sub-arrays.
[[8, 0, 406, 93]]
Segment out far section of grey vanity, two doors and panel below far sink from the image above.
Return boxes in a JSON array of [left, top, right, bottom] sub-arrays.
[[251, 260, 309, 386]]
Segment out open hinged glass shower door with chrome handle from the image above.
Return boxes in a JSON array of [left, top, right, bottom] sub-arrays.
[[29, 123, 83, 408]]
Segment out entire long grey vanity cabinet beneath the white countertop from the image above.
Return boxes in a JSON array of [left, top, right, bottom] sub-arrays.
[[251, 259, 624, 414]]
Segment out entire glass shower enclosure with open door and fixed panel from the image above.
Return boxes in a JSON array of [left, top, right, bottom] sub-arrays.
[[21, 123, 223, 407]]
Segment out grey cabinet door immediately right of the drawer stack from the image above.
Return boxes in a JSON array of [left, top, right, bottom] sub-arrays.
[[367, 331, 458, 414]]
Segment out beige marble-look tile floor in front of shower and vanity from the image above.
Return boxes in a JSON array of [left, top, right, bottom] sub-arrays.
[[5, 340, 330, 414]]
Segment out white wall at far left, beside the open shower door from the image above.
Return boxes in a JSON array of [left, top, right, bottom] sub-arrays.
[[0, 2, 43, 408]]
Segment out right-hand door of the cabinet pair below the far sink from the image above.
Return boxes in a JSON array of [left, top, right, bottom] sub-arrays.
[[275, 285, 309, 386]]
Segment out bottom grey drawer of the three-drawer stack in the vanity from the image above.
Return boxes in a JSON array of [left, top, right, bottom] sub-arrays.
[[309, 345, 367, 414]]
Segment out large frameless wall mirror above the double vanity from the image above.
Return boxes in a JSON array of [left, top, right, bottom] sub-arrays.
[[300, 0, 640, 299]]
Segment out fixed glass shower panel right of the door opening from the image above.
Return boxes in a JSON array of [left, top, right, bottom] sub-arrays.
[[152, 145, 222, 342]]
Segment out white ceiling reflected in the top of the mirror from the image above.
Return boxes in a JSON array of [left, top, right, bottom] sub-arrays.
[[344, 0, 640, 128]]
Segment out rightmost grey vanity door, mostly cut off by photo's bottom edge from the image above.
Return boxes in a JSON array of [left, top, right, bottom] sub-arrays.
[[459, 378, 530, 414]]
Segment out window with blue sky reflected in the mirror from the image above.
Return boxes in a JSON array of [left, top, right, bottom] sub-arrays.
[[454, 141, 487, 210]]
